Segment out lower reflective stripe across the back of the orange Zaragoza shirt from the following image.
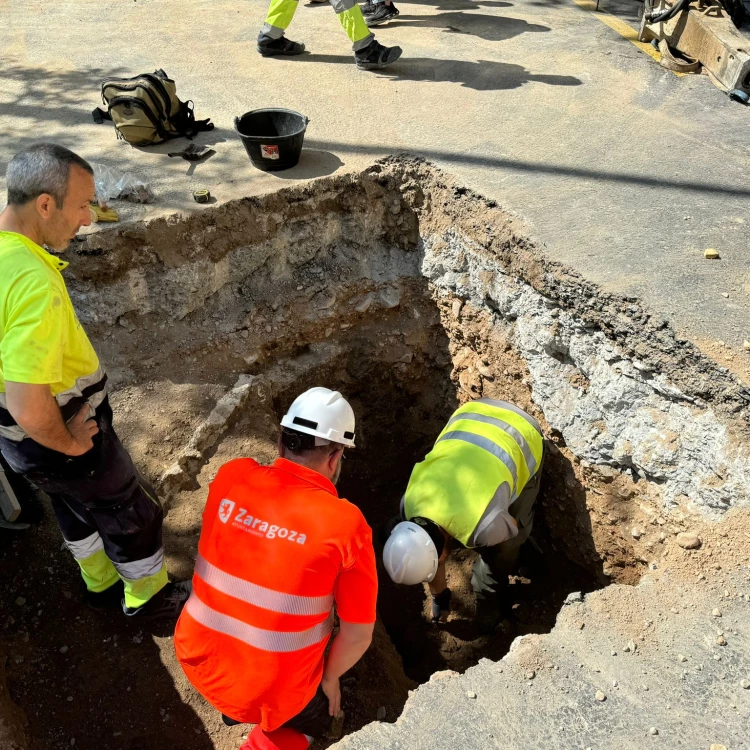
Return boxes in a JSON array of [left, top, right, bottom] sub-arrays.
[[185, 591, 333, 653]]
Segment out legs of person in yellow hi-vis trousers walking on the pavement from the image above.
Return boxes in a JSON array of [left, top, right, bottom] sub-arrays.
[[258, 0, 401, 70]]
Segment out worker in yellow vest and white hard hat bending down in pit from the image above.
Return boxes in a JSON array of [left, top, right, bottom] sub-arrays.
[[383, 398, 544, 626]]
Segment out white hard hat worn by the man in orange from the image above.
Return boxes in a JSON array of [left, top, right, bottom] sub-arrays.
[[281, 387, 354, 448]]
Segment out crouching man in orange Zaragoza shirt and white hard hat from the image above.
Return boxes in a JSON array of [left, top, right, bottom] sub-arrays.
[[175, 388, 378, 750]]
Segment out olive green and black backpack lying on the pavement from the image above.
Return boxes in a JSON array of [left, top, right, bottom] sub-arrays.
[[92, 70, 214, 146]]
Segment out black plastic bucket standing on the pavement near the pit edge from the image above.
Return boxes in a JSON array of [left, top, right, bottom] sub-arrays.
[[234, 109, 310, 172]]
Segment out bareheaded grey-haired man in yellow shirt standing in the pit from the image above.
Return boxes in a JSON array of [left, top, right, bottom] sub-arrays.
[[0, 144, 190, 619]]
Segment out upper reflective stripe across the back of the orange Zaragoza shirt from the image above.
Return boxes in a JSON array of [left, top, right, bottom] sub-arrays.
[[195, 555, 333, 615]]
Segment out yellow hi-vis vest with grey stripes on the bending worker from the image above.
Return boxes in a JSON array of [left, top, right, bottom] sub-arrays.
[[403, 398, 543, 546]]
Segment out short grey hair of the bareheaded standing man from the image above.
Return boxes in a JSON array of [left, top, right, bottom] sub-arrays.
[[5, 143, 94, 208]]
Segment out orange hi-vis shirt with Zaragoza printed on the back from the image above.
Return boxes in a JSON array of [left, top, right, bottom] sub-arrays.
[[175, 458, 377, 731]]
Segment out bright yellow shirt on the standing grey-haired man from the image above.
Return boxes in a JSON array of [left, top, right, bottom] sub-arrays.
[[0, 232, 104, 403]]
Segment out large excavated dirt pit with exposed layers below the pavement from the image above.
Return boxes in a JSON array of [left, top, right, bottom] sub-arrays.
[[0, 160, 750, 750]]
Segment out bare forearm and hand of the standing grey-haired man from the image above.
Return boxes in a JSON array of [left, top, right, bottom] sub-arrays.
[[5, 381, 99, 456]]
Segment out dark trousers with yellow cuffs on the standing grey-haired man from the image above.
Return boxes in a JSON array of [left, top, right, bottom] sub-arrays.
[[0, 400, 167, 608]]
